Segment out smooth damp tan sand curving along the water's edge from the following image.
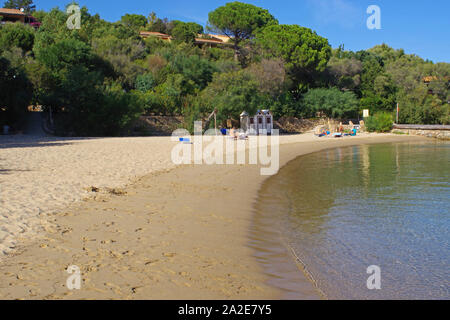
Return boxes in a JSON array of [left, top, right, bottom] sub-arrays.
[[0, 135, 425, 300]]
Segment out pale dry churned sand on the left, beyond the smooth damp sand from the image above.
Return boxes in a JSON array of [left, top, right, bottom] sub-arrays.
[[0, 135, 179, 255]]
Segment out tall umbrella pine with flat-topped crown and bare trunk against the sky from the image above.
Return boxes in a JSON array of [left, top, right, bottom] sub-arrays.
[[208, 1, 278, 60]]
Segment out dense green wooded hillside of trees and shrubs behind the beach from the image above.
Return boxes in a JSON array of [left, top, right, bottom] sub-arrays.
[[0, 2, 450, 136]]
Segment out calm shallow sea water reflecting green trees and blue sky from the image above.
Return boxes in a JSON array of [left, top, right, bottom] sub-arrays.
[[256, 142, 450, 299]]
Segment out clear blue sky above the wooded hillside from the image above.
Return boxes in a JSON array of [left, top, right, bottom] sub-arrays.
[[25, 0, 450, 62]]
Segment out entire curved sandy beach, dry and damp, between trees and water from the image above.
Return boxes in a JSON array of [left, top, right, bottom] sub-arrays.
[[0, 133, 425, 299]]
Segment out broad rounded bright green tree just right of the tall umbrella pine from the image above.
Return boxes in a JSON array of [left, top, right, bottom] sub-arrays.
[[256, 25, 331, 90]]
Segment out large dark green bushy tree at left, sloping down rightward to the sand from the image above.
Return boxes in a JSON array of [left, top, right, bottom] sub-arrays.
[[36, 38, 142, 136]]
